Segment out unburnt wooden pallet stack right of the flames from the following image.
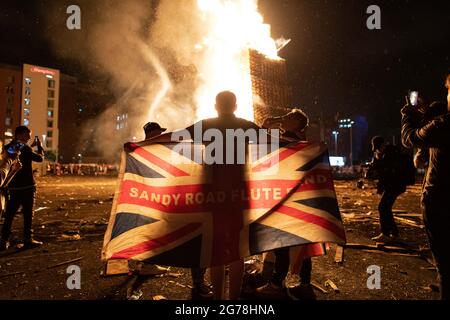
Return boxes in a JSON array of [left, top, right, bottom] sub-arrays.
[[250, 50, 292, 125]]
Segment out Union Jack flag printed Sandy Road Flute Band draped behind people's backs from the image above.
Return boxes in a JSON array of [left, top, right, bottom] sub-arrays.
[[102, 142, 346, 267]]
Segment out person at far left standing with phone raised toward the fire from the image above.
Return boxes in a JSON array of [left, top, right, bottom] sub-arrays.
[[0, 126, 44, 251]]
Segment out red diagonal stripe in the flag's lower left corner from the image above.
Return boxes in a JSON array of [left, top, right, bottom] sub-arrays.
[[111, 223, 202, 259]]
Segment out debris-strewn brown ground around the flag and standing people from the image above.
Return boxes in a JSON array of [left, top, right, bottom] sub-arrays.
[[0, 177, 438, 300]]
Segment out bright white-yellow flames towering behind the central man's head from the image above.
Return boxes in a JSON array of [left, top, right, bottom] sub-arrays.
[[193, 0, 279, 120]]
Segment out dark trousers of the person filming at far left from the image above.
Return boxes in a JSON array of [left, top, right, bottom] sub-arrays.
[[1, 186, 36, 242]]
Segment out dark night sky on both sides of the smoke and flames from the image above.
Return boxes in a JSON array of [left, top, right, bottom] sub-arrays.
[[0, 0, 450, 133]]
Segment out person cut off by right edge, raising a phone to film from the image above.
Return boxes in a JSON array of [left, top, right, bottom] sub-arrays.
[[401, 74, 450, 300]]
